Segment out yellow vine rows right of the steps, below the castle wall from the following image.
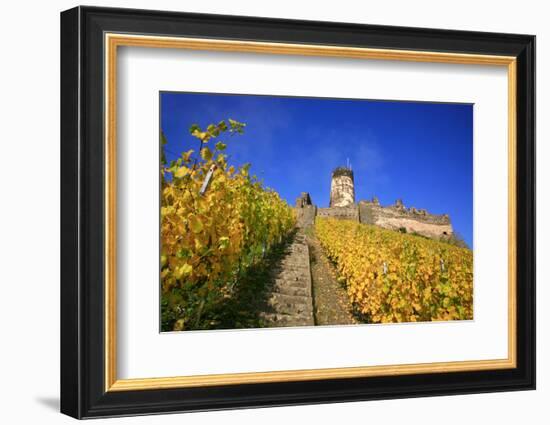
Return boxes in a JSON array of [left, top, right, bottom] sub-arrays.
[[315, 217, 473, 323]]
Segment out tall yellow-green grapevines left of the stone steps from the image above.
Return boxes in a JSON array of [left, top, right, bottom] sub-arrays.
[[161, 120, 295, 331]]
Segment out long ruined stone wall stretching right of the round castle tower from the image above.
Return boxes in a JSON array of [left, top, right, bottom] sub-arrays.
[[359, 202, 453, 239]]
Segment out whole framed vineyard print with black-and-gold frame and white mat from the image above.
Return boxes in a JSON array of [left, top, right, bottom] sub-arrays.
[[61, 7, 535, 418]]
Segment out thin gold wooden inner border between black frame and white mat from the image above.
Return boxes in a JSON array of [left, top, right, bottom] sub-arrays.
[[104, 33, 517, 392]]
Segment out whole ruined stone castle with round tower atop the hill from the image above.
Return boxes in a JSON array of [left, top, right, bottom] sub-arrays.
[[296, 167, 453, 239]]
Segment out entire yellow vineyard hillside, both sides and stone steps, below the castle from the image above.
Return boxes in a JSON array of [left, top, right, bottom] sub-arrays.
[[160, 119, 473, 331]]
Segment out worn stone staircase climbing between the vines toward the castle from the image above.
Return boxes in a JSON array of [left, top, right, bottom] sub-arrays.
[[260, 229, 315, 327]]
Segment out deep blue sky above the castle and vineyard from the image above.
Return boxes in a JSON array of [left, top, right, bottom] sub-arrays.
[[161, 92, 473, 247]]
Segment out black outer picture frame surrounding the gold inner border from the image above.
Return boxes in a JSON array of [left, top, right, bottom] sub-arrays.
[[61, 7, 535, 418]]
